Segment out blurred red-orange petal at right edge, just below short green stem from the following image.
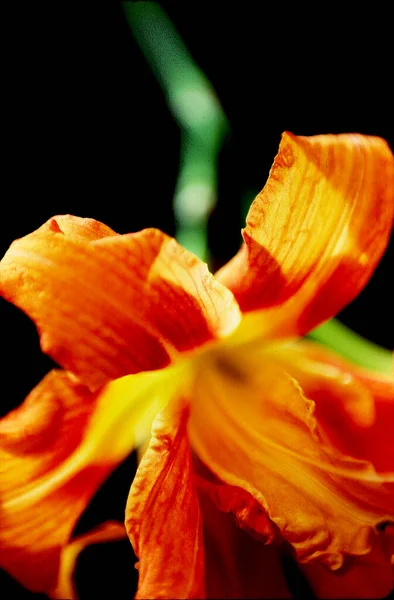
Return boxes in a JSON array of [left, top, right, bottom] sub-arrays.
[[274, 341, 394, 472]]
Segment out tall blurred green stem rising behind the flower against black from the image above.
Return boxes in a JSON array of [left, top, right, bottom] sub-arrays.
[[124, 2, 229, 261]]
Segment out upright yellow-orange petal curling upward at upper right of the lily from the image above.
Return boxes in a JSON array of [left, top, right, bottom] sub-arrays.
[[216, 133, 394, 337]]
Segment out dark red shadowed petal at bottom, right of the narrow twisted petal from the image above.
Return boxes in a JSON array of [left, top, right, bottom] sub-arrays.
[[194, 459, 291, 599]]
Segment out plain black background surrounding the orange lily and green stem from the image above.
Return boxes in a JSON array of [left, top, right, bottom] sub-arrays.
[[0, 1, 394, 598]]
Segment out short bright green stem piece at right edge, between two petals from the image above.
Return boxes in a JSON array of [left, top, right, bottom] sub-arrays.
[[308, 319, 393, 374]]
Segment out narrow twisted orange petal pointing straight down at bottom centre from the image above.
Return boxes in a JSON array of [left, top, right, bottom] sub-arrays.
[[125, 402, 205, 598]]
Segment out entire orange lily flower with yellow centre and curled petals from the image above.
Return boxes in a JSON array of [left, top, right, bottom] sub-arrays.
[[0, 133, 394, 598]]
